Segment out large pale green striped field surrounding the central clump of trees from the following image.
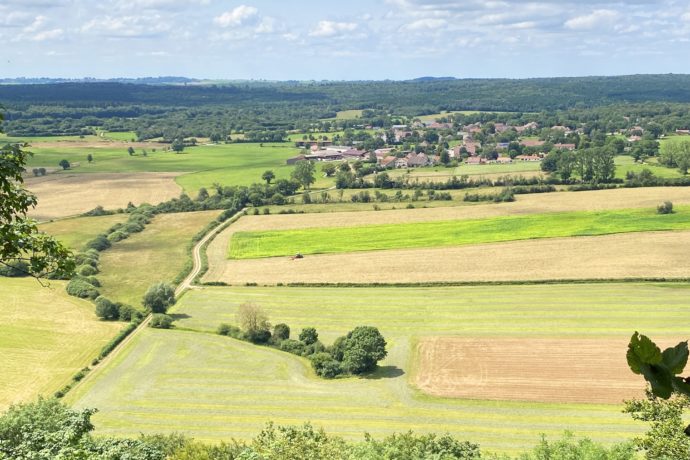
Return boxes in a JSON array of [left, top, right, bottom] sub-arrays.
[[64, 284, 690, 451]]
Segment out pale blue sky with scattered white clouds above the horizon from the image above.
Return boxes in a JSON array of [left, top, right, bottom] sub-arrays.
[[0, 0, 690, 80]]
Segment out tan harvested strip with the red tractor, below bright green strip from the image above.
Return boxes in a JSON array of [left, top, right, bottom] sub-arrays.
[[204, 231, 690, 285]]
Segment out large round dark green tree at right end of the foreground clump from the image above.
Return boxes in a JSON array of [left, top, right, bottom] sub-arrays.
[[342, 326, 387, 374]]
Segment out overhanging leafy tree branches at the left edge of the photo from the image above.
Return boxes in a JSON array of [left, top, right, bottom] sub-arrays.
[[0, 133, 75, 278]]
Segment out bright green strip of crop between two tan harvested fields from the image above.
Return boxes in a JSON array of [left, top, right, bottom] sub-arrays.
[[229, 208, 690, 259]]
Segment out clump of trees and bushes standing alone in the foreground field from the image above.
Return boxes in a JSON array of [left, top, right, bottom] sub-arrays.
[[217, 303, 387, 379]]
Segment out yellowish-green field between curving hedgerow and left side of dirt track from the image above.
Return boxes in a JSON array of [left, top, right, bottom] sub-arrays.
[[98, 211, 220, 306]]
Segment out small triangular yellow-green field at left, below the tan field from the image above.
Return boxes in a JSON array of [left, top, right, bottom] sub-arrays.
[[39, 214, 128, 251]]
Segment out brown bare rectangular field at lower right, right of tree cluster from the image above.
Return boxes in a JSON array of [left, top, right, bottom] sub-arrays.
[[413, 337, 660, 404]]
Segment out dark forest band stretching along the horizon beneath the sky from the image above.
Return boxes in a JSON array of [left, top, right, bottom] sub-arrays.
[[0, 75, 690, 139]]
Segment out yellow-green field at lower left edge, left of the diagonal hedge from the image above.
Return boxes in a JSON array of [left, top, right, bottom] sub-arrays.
[[0, 278, 122, 410]]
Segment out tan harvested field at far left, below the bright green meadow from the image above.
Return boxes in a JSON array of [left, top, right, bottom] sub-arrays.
[[26, 173, 182, 221]]
